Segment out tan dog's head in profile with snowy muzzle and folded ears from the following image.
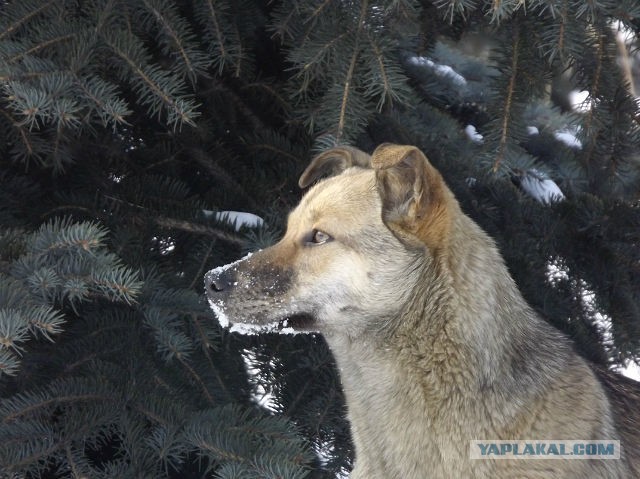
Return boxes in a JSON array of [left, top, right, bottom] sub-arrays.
[[205, 144, 455, 336]]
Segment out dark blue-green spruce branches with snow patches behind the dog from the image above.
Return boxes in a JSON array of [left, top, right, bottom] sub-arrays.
[[0, 0, 640, 478]]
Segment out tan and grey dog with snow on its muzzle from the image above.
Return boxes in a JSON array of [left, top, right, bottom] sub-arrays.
[[205, 144, 640, 479]]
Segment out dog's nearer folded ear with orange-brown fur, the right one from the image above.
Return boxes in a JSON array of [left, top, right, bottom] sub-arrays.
[[371, 143, 452, 251]]
